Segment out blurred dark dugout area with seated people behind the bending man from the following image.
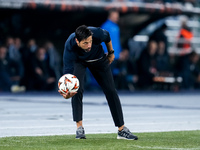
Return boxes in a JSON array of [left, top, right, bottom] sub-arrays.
[[0, 0, 200, 92]]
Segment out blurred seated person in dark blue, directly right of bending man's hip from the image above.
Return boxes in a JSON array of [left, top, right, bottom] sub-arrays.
[[112, 49, 138, 91]]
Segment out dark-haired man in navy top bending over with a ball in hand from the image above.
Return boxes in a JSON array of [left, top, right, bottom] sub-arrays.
[[59, 25, 138, 140]]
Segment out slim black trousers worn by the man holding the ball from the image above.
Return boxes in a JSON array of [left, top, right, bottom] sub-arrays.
[[72, 56, 124, 127]]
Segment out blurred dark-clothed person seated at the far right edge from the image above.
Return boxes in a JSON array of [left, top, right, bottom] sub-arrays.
[[177, 51, 200, 89]]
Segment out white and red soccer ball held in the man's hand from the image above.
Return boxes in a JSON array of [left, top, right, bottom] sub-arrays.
[[58, 74, 79, 93]]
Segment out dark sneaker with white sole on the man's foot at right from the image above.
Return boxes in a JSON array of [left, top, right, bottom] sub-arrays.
[[117, 127, 138, 140]]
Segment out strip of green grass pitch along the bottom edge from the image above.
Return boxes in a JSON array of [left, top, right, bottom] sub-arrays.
[[0, 130, 200, 150]]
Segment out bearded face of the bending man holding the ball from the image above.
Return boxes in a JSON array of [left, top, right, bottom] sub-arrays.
[[76, 36, 92, 52]]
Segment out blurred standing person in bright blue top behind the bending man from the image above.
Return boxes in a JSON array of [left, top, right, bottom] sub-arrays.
[[101, 10, 122, 59]]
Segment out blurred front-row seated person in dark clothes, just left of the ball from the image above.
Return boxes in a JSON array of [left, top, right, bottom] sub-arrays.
[[29, 47, 56, 91]]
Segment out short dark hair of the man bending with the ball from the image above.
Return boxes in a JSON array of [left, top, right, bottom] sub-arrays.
[[75, 25, 92, 42]]
